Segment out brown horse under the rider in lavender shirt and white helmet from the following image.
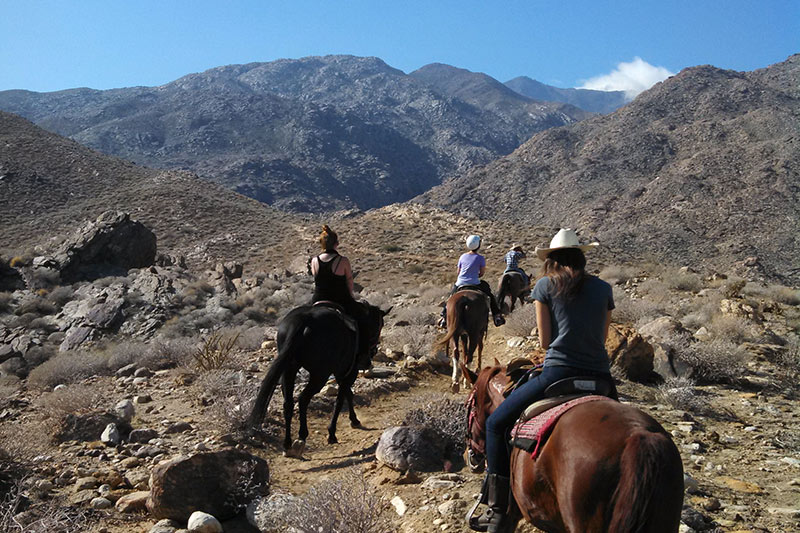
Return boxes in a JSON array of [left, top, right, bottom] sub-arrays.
[[435, 289, 489, 392]]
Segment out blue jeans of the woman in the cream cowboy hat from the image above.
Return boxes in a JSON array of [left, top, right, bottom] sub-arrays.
[[486, 366, 610, 477]]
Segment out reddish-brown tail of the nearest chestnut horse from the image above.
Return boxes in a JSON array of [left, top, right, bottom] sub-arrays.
[[608, 430, 683, 533]]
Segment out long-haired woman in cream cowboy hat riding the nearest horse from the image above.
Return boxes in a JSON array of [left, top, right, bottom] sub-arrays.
[[470, 229, 616, 532]]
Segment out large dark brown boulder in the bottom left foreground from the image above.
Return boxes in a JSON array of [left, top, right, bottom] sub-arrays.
[[147, 448, 269, 522]]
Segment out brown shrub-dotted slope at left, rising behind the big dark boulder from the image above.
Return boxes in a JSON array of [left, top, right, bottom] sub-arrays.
[[0, 111, 304, 264]]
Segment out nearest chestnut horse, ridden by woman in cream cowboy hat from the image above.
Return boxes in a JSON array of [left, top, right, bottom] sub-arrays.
[[465, 366, 683, 533]]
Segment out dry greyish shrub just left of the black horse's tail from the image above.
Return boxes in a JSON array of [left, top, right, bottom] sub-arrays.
[[192, 370, 260, 433]]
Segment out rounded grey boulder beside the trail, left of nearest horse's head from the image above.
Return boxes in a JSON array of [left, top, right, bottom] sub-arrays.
[[375, 426, 446, 472]]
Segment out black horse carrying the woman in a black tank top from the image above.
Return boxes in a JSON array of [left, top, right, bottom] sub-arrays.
[[250, 303, 391, 457]]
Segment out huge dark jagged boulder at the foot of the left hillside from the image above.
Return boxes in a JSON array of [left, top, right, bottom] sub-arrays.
[[53, 211, 156, 282]]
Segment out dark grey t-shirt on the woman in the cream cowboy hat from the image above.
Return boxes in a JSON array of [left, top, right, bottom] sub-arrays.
[[533, 275, 614, 372]]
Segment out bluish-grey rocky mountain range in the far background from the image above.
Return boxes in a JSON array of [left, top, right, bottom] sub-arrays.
[[0, 56, 585, 211]]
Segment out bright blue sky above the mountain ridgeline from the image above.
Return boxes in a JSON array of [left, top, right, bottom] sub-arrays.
[[0, 0, 800, 91]]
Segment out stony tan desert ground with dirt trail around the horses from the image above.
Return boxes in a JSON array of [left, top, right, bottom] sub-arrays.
[[0, 208, 800, 533]]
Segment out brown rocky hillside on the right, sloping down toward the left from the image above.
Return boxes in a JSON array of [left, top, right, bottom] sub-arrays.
[[420, 55, 800, 283]]
